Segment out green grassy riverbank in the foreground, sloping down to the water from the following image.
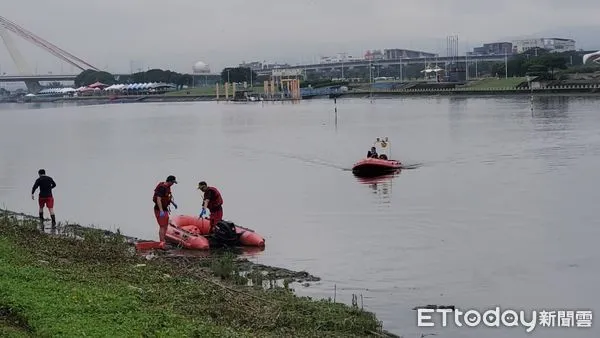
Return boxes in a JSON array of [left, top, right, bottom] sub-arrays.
[[0, 214, 383, 337]]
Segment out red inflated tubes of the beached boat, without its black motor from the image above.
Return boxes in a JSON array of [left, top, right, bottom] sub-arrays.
[[165, 215, 265, 250]]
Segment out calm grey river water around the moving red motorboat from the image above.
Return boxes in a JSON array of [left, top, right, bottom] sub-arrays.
[[0, 97, 600, 337]]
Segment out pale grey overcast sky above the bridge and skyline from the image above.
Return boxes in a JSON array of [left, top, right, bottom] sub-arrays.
[[0, 0, 600, 74]]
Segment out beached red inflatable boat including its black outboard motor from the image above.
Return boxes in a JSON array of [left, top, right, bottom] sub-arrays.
[[136, 215, 265, 250]]
